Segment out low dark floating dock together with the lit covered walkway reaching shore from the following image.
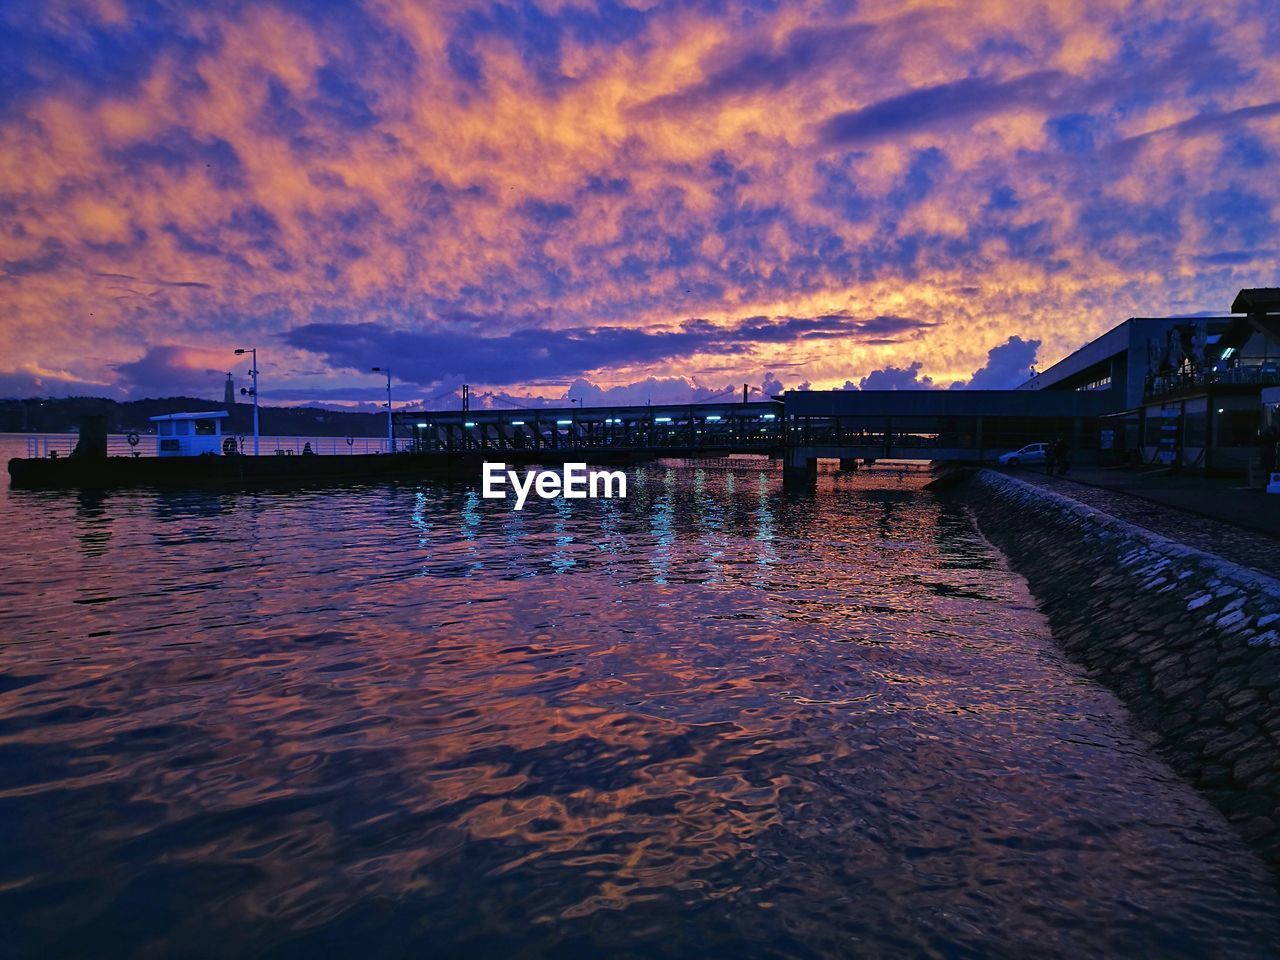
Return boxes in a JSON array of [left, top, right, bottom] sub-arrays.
[[9, 390, 1111, 486]]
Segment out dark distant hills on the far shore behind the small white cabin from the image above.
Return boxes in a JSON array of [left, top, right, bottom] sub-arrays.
[[0, 397, 387, 436]]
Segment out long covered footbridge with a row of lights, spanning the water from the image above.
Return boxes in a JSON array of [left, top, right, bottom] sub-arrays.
[[396, 390, 1116, 483]]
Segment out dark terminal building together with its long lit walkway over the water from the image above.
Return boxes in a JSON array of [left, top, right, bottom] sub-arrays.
[[394, 288, 1280, 481]]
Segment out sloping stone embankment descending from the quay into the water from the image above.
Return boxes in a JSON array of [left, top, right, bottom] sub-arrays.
[[954, 470, 1280, 870]]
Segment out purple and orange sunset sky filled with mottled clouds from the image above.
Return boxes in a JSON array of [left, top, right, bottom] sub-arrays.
[[0, 0, 1280, 407]]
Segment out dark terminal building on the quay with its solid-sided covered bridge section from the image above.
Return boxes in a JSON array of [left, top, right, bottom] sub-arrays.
[[782, 288, 1280, 481]]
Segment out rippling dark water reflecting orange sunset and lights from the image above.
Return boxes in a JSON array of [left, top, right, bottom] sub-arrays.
[[0, 448, 1280, 960]]
